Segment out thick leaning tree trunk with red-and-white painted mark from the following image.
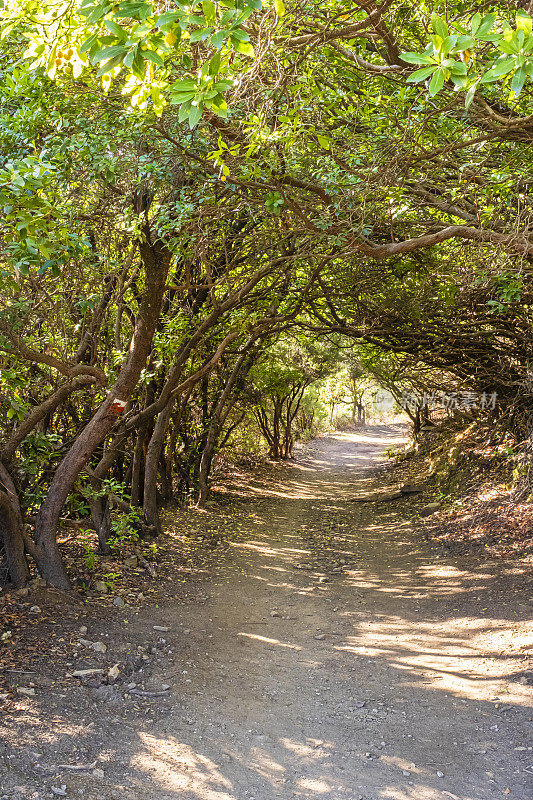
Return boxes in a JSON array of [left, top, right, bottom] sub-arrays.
[[35, 236, 171, 589]]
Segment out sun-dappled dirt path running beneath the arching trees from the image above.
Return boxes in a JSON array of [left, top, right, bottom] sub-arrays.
[[0, 427, 533, 800]]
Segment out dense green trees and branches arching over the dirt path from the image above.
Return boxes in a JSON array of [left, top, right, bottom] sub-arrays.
[[0, 0, 533, 588]]
